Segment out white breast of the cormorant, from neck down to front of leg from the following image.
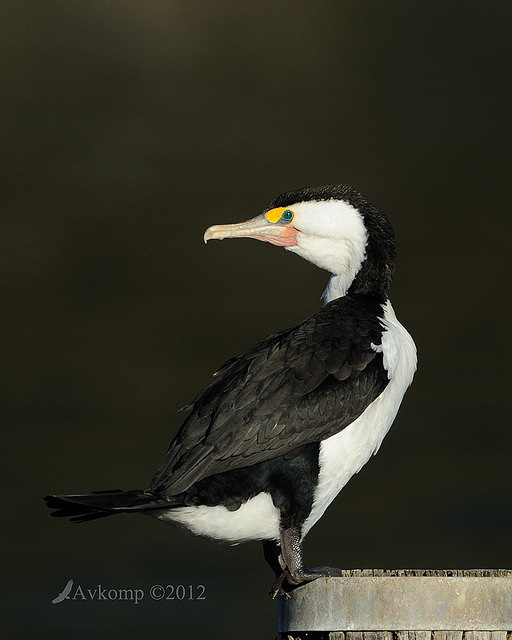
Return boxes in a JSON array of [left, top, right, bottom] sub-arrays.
[[302, 300, 417, 538]]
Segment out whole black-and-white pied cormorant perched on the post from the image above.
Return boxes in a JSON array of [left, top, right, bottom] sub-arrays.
[[46, 185, 416, 595]]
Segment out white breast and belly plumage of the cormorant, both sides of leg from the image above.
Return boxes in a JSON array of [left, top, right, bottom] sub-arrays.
[[153, 301, 416, 544]]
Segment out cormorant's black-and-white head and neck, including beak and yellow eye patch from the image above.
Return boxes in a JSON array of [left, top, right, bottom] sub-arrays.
[[204, 185, 396, 299]]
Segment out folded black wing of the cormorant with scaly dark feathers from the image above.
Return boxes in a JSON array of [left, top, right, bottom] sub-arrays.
[[151, 296, 388, 495]]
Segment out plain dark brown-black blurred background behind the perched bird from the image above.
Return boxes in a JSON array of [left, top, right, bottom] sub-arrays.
[[0, 0, 512, 640]]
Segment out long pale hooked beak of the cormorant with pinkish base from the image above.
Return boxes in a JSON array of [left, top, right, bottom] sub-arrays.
[[204, 214, 298, 247]]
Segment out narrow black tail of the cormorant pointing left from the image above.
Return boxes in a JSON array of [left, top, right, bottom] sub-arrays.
[[45, 489, 171, 522]]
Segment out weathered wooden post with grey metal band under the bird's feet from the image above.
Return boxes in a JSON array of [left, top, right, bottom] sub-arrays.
[[278, 569, 512, 640]]
